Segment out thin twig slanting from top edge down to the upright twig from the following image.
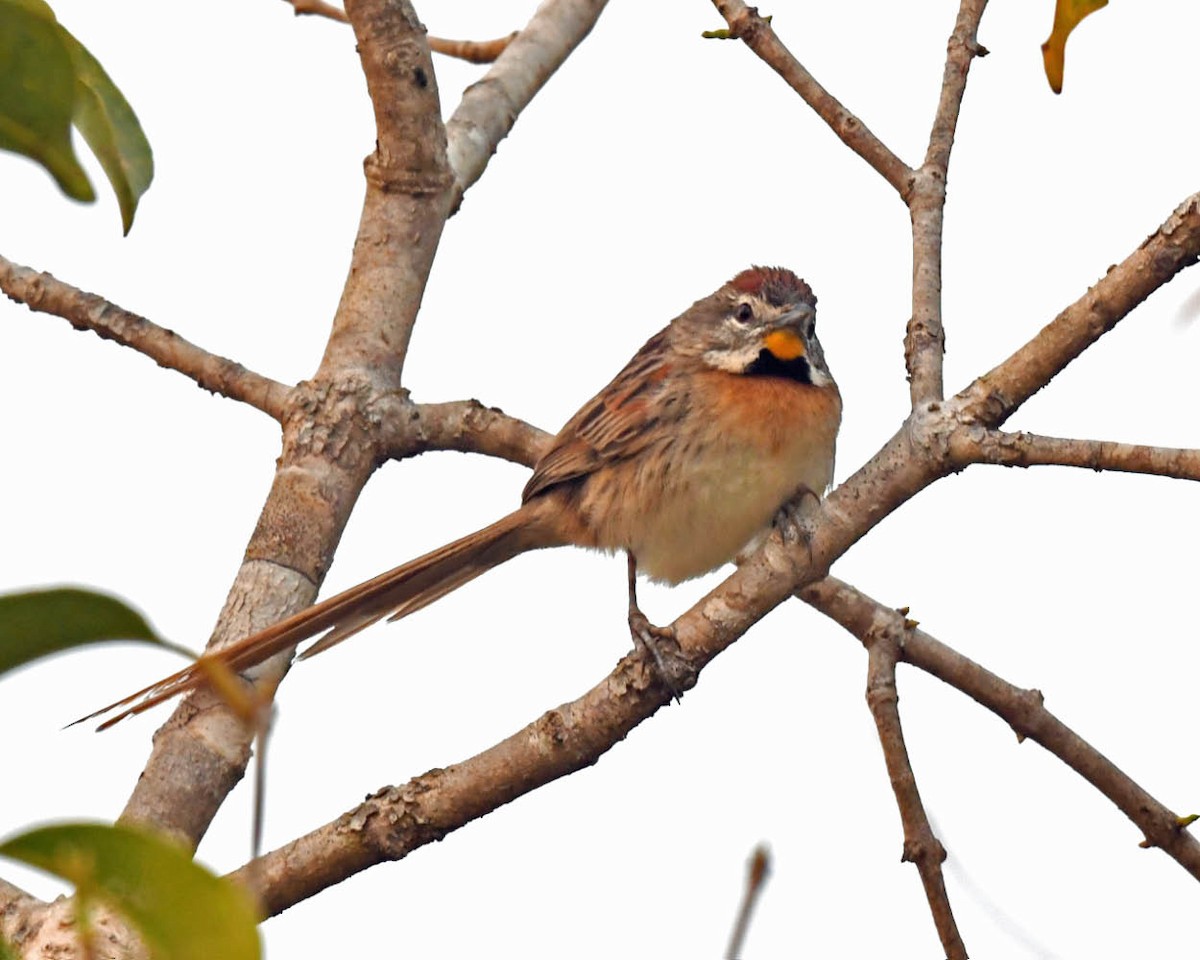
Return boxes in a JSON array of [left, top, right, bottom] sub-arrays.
[[713, 0, 913, 197]]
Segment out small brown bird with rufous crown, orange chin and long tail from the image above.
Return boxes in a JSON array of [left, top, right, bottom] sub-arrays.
[[84, 266, 841, 730]]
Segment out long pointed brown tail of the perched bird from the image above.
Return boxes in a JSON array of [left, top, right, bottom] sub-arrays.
[[84, 500, 564, 730]]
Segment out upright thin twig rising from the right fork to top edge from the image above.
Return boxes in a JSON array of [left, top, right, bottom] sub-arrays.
[[904, 0, 988, 408]]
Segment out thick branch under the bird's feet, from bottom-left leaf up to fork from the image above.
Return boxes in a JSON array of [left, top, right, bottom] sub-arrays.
[[218, 414, 955, 914]]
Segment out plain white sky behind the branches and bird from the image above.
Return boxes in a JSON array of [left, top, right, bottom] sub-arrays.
[[0, 0, 1200, 960]]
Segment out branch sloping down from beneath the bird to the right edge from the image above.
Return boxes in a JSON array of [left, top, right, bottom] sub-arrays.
[[800, 577, 1200, 880]]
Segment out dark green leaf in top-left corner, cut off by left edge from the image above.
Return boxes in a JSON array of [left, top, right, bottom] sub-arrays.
[[0, 0, 96, 200]]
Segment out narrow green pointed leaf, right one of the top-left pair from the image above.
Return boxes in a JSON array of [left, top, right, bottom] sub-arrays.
[[59, 28, 154, 234]]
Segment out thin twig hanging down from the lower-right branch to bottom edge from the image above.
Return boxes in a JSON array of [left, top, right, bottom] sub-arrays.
[[859, 618, 967, 960]]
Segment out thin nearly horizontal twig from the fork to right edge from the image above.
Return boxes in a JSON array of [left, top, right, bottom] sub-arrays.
[[955, 430, 1200, 480]]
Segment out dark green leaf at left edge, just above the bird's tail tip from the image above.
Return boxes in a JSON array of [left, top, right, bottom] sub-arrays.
[[0, 587, 178, 673]]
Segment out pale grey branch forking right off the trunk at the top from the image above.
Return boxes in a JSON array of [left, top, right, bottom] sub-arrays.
[[446, 0, 607, 209]]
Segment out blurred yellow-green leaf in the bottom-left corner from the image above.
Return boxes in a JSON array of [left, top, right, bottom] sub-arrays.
[[0, 823, 262, 960]]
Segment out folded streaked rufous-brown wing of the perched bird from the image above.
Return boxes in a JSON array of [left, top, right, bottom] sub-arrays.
[[522, 330, 683, 502]]
